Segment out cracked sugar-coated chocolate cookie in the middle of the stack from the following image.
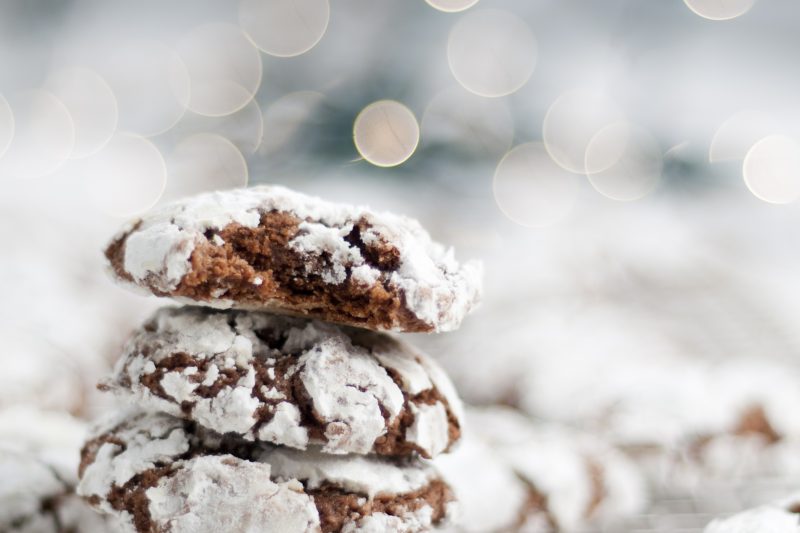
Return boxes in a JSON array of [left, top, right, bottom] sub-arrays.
[[104, 307, 461, 457]]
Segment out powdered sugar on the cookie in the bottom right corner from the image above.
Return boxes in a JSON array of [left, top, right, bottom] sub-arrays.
[[703, 494, 800, 533]]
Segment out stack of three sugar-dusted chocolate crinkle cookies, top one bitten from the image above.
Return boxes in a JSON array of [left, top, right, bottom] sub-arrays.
[[78, 186, 481, 533]]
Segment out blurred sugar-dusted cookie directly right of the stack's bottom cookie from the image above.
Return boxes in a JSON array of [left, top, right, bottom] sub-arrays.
[[437, 407, 648, 532]]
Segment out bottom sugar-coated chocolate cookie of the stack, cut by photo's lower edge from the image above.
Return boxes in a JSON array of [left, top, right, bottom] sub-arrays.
[[78, 414, 453, 533]]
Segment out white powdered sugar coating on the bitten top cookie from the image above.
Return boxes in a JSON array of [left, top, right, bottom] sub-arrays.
[[106, 186, 482, 331]]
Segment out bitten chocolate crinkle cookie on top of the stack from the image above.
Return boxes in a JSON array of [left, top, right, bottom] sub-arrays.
[[106, 186, 481, 331]]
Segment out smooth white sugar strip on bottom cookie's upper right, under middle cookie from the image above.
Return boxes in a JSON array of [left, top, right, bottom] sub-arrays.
[[260, 442, 435, 497]]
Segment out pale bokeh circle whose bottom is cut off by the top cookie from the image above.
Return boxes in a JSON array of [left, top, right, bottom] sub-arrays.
[[163, 133, 247, 200]]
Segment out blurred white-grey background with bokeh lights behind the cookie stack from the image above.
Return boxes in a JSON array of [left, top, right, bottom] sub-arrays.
[[0, 0, 800, 531]]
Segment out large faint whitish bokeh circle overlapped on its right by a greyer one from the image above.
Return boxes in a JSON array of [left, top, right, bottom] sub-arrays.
[[101, 41, 190, 136]]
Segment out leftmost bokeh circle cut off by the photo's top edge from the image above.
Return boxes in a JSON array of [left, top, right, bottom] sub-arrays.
[[239, 0, 331, 57]]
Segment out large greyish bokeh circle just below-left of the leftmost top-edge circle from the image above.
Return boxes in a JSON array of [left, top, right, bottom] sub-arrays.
[[178, 23, 261, 117]]
